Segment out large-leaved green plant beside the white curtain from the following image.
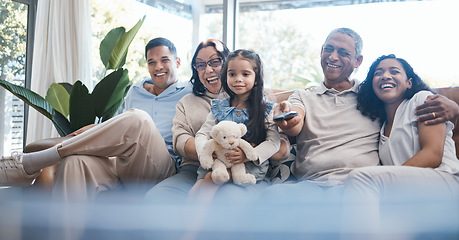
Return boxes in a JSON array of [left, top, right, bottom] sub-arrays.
[[0, 16, 145, 136]]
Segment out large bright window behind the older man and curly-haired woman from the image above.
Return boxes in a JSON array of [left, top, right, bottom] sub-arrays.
[[201, 0, 459, 89]]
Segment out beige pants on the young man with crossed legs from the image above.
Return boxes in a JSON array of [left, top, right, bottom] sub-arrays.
[[52, 110, 176, 239]]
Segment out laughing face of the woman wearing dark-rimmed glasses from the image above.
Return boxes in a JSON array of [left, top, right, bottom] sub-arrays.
[[196, 46, 222, 93]]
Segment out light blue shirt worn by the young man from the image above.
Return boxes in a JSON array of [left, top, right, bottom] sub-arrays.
[[123, 78, 193, 168]]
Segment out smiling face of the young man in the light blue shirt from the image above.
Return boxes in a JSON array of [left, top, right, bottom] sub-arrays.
[[147, 46, 180, 94]]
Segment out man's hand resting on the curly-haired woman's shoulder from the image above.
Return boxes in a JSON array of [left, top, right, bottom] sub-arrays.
[[415, 94, 459, 125]]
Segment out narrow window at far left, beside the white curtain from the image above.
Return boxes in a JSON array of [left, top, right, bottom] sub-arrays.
[[0, 0, 28, 154]]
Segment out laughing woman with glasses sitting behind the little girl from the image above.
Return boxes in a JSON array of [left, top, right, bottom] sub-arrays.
[[146, 39, 229, 203]]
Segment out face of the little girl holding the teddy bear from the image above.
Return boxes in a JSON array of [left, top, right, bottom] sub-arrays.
[[226, 56, 256, 101]]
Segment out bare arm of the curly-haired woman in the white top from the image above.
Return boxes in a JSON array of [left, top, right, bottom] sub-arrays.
[[403, 121, 446, 168]]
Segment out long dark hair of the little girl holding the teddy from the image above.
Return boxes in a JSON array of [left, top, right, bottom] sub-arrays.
[[220, 49, 267, 144]]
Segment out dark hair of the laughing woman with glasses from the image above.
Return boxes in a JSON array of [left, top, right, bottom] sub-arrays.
[[190, 39, 229, 96]]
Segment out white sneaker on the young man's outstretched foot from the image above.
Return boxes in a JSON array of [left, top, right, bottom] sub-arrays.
[[0, 152, 40, 187]]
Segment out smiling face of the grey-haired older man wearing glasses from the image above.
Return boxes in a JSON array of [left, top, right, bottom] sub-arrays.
[[320, 33, 363, 87]]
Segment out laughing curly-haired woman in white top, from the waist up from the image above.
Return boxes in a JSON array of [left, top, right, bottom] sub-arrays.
[[357, 54, 459, 170]]
